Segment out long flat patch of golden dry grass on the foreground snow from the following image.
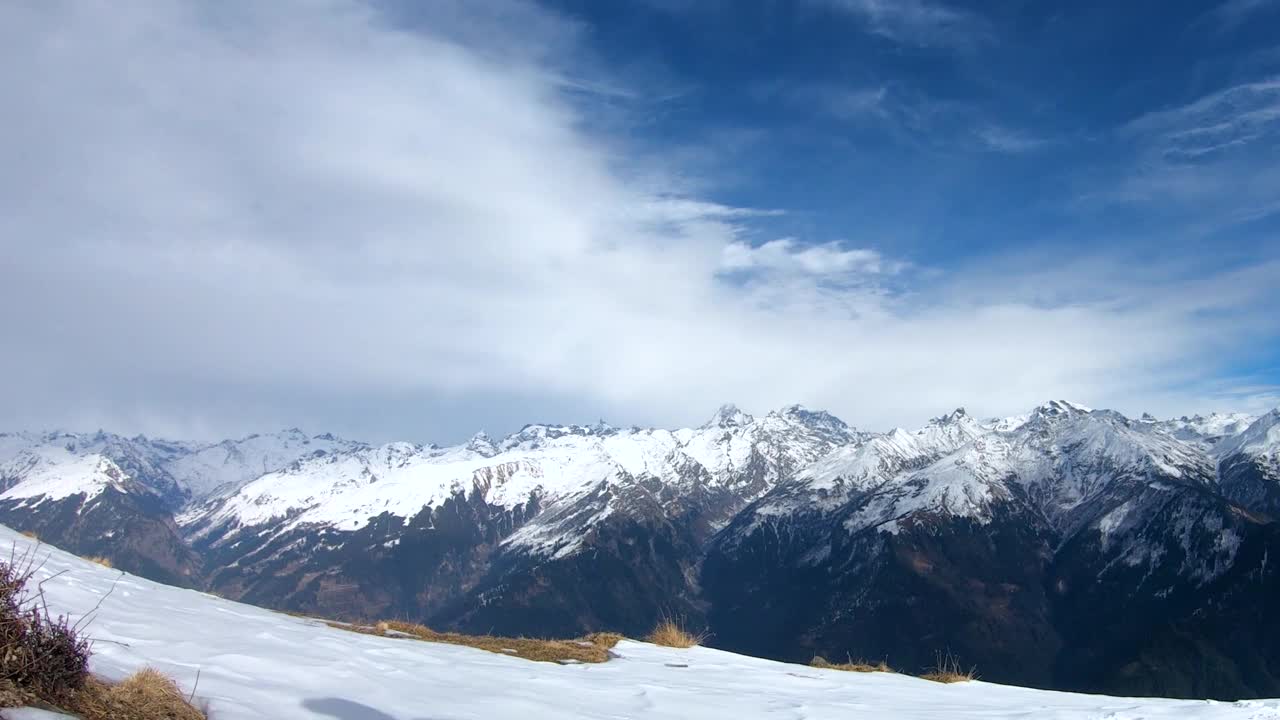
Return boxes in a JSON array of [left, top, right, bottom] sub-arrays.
[[328, 620, 622, 662]]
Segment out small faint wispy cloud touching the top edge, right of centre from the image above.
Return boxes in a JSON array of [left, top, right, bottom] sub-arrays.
[[822, 0, 993, 49]]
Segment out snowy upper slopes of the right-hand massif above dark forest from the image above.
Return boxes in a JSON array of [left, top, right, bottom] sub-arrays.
[[744, 401, 1215, 532]]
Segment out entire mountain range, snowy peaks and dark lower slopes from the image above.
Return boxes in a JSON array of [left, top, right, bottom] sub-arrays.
[[0, 401, 1280, 700]]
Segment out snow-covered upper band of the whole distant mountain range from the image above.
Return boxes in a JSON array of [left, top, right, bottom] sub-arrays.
[[0, 401, 1280, 530]]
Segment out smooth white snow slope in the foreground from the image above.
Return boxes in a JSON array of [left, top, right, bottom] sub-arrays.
[[0, 527, 1280, 720]]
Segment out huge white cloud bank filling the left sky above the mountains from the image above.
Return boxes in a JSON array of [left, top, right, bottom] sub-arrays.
[[0, 0, 1266, 441]]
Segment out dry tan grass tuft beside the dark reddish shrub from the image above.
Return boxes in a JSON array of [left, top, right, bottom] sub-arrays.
[[67, 667, 205, 720]]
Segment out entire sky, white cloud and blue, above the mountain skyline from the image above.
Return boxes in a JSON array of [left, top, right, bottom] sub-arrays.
[[0, 0, 1280, 443]]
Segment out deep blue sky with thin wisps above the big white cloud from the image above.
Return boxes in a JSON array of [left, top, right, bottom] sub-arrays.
[[540, 0, 1280, 258]]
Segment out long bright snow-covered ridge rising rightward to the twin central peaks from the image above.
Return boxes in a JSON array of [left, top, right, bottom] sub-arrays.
[[178, 406, 859, 553]]
